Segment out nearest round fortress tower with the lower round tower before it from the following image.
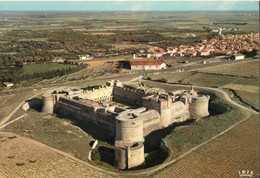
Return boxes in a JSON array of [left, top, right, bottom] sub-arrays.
[[115, 112, 144, 169]]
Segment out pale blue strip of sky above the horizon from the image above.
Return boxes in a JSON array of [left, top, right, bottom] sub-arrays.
[[0, 0, 259, 11]]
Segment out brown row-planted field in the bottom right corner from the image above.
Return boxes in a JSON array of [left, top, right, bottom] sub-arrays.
[[153, 115, 259, 178]]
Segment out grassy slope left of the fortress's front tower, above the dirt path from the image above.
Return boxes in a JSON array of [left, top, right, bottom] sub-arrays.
[[5, 110, 92, 161]]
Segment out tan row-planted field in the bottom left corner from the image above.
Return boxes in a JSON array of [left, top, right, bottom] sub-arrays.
[[0, 132, 110, 178]]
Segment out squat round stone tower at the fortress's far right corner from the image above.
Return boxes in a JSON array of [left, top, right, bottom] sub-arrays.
[[189, 95, 209, 118]]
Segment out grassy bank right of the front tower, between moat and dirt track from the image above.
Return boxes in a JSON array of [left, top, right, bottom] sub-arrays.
[[165, 90, 245, 158]]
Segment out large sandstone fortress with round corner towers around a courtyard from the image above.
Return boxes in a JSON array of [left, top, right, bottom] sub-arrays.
[[42, 80, 209, 169]]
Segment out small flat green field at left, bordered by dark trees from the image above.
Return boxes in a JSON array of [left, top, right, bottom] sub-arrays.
[[24, 63, 76, 75]]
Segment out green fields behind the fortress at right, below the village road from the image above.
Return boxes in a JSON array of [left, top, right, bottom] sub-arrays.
[[146, 60, 259, 110]]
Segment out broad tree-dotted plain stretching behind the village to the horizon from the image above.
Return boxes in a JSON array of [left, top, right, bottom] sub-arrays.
[[0, 12, 259, 83]]
